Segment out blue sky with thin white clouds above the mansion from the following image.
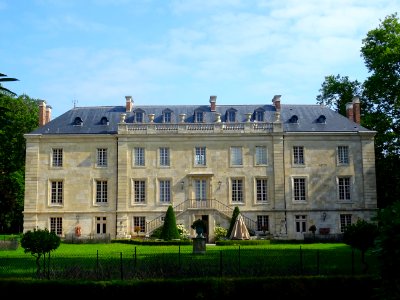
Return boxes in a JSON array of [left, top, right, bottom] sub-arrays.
[[0, 0, 399, 119]]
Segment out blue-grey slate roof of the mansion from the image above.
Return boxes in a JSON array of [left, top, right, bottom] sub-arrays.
[[30, 104, 370, 134]]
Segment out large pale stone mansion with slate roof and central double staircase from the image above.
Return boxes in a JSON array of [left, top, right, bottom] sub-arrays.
[[24, 96, 377, 242]]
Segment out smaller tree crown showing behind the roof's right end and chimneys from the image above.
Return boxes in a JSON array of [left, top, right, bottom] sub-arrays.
[[317, 74, 362, 116]]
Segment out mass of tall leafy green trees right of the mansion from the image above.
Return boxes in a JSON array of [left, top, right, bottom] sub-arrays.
[[317, 13, 400, 207]]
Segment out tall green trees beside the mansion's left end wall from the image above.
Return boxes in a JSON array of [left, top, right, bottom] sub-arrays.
[[0, 93, 39, 232]]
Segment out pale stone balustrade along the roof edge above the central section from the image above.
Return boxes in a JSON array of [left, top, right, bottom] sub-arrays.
[[118, 122, 282, 134]]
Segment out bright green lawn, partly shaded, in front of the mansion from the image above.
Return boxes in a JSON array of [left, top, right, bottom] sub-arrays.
[[0, 243, 377, 279]]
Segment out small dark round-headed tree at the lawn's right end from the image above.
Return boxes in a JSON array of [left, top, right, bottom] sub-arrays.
[[343, 219, 378, 272]]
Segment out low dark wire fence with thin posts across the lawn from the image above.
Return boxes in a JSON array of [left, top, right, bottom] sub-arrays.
[[0, 246, 378, 280]]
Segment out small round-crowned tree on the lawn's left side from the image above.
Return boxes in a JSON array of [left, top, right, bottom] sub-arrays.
[[21, 228, 61, 278]]
